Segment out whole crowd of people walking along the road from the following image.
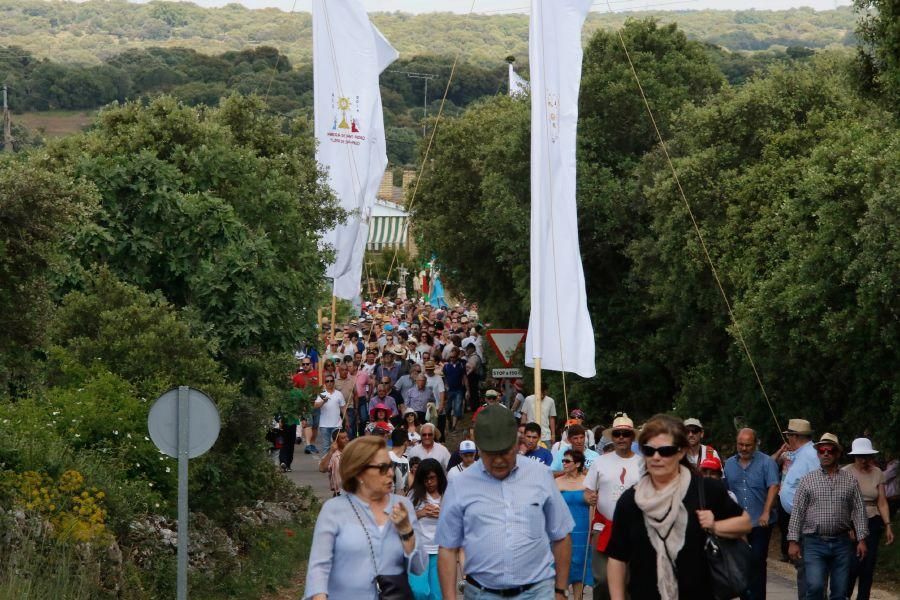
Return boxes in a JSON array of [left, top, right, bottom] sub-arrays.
[[292, 299, 898, 600]]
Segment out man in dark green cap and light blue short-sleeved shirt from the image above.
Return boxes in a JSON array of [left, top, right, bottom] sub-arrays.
[[435, 405, 575, 600]]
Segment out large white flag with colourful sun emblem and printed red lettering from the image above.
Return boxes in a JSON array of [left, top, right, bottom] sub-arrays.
[[313, 0, 398, 300]]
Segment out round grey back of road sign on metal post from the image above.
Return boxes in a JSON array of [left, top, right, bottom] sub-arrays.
[[147, 387, 221, 458]]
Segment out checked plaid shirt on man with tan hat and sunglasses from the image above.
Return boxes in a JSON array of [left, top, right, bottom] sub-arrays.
[[788, 468, 869, 542]]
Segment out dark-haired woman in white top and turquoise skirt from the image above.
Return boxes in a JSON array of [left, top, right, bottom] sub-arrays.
[[409, 458, 447, 600]]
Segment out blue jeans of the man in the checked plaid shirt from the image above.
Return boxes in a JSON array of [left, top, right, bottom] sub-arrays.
[[803, 535, 855, 600]]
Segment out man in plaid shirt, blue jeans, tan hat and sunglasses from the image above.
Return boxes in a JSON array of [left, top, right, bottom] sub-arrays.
[[788, 433, 869, 600]]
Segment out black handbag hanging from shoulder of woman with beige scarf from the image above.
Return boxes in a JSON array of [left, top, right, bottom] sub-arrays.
[[697, 479, 753, 600]]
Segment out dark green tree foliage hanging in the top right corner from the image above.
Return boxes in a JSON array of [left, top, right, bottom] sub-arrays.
[[853, 0, 900, 106]]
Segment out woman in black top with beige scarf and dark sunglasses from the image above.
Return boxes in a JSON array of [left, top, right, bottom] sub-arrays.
[[607, 415, 751, 600]]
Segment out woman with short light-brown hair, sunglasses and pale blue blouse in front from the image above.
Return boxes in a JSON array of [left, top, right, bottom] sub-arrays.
[[304, 436, 428, 600]]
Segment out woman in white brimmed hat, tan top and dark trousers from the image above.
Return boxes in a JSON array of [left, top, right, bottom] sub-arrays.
[[844, 438, 894, 600]]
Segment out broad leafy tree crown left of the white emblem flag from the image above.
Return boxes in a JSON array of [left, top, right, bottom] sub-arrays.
[[50, 96, 340, 354]]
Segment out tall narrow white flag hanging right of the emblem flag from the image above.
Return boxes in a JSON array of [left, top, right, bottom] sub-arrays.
[[525, 0, 596, 377]]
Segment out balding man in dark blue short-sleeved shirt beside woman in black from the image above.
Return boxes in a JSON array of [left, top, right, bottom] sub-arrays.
[[725, 429, 780, 600]]
